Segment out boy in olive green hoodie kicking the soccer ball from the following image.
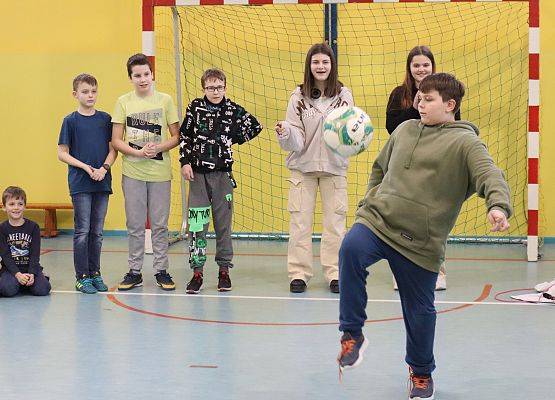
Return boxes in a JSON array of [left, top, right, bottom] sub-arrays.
[[338, 73, 512, 399]]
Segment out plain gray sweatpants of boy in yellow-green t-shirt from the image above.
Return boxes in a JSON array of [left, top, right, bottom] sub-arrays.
[[121, 175, 171, 273]]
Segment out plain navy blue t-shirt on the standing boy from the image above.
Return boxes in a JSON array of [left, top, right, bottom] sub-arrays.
[[58, 110, 112, 195]]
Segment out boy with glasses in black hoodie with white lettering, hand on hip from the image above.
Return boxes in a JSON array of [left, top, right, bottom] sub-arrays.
[[179, 69, 262, 294]]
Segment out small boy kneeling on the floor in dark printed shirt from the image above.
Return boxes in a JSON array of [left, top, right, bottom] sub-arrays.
[[0, 186, 50, 297]]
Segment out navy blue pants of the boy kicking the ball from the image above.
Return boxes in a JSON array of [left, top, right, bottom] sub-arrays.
[[339, 224, 438, 375]]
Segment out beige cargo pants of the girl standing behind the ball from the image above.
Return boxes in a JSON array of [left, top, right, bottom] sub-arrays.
[[287, 170, 347, 283]]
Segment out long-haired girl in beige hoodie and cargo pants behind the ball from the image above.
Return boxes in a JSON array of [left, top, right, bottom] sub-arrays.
[[276, 43, 353, 293]]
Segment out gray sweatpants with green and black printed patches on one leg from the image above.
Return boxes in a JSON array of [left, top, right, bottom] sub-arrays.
[[189, 171, 233, 268]]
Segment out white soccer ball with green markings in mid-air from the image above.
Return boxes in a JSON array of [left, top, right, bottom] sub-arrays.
[[324, 106, 374, 157]]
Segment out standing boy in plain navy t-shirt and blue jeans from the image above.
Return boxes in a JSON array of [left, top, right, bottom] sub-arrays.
[[58, 74, 117, 294]]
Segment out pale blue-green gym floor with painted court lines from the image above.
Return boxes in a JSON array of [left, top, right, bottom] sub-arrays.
[[0, 235, 555, 400]]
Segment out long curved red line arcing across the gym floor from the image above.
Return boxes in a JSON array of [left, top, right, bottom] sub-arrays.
[[107, 283, 492, 326]]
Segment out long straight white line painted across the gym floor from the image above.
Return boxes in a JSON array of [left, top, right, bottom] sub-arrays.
[[51, 290, 551, 306]]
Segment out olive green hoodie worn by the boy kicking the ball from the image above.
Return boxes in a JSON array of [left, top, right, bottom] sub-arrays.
[[355, 119, 512, 272]]
